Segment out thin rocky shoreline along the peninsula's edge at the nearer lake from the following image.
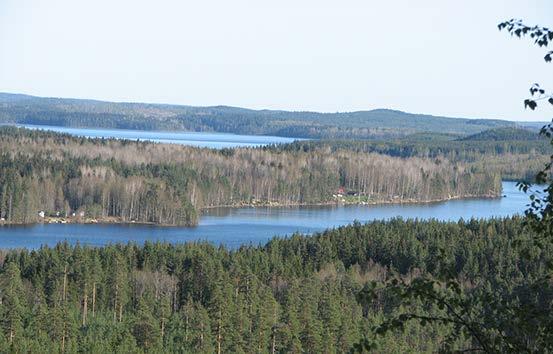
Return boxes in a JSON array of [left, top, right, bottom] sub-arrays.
[[0, 193, 502, 228]]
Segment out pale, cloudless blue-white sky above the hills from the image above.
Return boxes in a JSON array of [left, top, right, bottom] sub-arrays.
[[0, 0, 553, 120]]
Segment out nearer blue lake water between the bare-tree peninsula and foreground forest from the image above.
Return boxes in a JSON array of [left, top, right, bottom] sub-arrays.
[[0, 182, 528, 248]]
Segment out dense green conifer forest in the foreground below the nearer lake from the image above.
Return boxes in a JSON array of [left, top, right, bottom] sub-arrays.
[[0, 218, 553, 353]]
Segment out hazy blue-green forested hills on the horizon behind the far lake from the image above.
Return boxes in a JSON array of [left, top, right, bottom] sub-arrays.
[[0, 93, 516, 139]]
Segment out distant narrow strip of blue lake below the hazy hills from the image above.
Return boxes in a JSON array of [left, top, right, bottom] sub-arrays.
[[17, 124, 298, 149]]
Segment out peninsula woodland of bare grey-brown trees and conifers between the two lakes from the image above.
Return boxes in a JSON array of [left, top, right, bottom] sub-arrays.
[[0, 127, 501, 225]]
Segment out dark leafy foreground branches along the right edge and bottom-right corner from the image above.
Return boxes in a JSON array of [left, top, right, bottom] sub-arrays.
[[351, 19, 553, 353]]
